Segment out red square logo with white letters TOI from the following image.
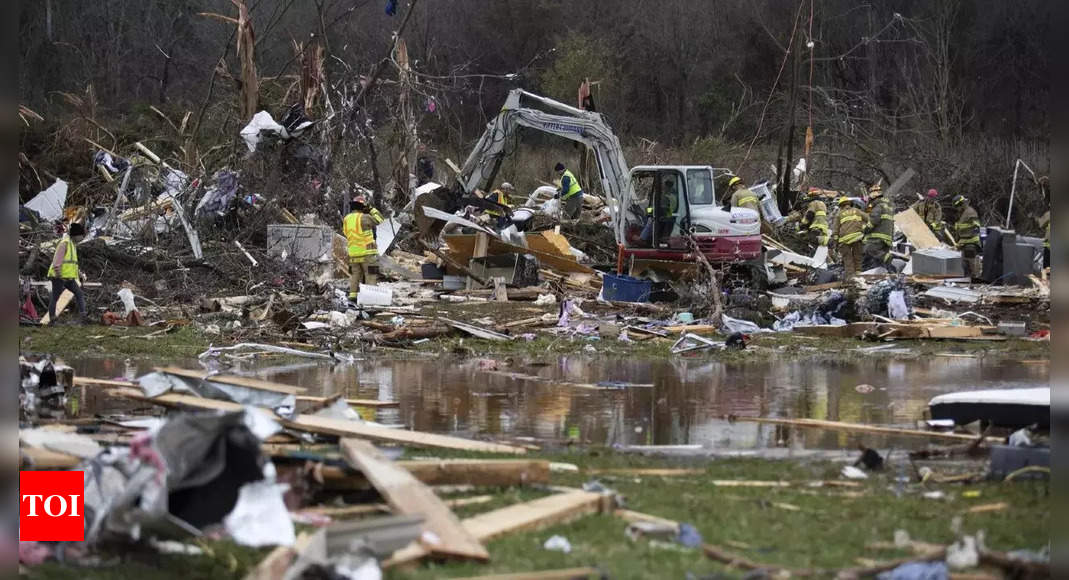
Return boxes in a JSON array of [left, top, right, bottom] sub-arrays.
[[18, 471, 86, 542]]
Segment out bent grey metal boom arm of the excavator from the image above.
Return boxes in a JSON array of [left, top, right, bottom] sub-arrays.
[[458, 89, 633, 240]]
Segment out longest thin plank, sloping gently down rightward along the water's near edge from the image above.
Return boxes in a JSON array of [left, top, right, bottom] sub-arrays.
[[110, 389, 527, 455]]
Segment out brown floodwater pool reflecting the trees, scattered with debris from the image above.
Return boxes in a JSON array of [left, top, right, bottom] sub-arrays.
[[67, 356, 1050, 450]]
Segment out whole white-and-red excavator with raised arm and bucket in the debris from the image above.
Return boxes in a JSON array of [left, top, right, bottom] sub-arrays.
[[415, 89, 762, 273]]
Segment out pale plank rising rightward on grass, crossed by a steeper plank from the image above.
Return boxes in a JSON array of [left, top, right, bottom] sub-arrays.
[[383, 489, 605, 568]]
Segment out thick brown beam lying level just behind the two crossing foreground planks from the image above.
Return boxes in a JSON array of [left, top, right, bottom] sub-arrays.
[[323, 459, 549, 489]]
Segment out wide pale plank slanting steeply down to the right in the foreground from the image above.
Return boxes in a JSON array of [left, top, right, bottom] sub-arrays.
[[339, 439, 490, 562]]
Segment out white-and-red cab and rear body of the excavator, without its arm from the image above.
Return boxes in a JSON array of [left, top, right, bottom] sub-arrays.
[[621, 166, 761, 267]]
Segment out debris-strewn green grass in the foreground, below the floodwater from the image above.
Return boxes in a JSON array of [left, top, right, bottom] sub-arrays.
[[30, 450, 1051, 580]]
